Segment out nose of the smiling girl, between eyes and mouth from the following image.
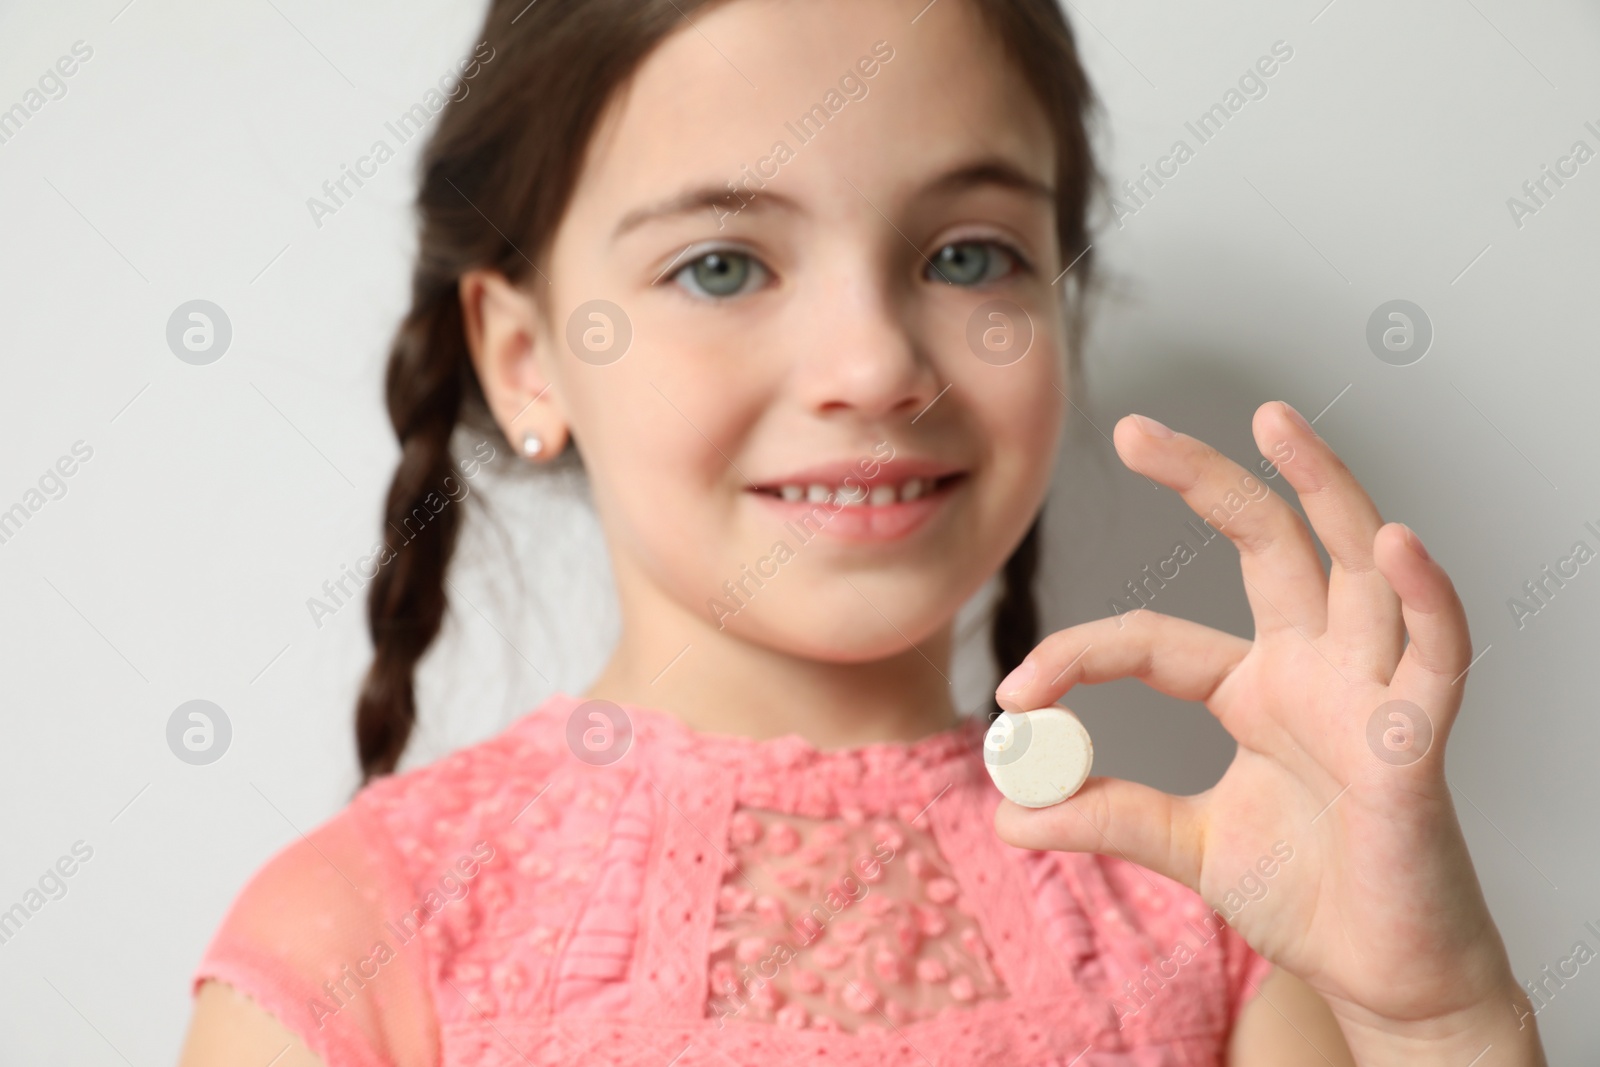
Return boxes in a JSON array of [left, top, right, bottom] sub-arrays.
[[795, 253, 939, 421]]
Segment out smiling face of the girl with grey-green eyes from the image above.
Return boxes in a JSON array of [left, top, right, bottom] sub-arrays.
[[478, 0, 1067, 662]]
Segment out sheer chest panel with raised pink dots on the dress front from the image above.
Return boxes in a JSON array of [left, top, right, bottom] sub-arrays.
[[710, 808, 1006, 1033]]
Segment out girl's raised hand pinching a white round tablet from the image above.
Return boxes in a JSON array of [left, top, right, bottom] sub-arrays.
[[995, 403, 1542, 1062]]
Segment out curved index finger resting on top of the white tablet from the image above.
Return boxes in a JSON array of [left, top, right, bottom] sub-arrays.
[[995, 611, 1251, 712]]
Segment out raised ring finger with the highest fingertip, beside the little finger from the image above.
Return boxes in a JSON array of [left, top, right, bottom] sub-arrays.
[[1253, 402, 1405, 681]]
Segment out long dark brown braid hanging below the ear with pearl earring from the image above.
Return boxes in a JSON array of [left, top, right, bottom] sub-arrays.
[[355, 280, 472, 785]]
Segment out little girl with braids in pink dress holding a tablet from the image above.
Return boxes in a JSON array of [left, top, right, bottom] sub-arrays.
[[182, 0, 1542, 1067]]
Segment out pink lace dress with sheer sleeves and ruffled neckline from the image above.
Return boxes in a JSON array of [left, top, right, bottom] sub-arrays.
[[194, 693, 1270, 1067]]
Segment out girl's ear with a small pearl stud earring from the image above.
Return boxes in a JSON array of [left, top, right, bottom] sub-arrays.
[[458, 269, 566, 459]]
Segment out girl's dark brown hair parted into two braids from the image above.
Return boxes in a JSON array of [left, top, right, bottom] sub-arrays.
[[355, 0, 1099, 784]]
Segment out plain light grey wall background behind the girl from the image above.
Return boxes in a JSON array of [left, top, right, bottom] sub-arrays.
[[0, 0, 1600, 1065]]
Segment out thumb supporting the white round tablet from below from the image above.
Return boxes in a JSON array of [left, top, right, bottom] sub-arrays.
[[995, 777, 1205, 889]]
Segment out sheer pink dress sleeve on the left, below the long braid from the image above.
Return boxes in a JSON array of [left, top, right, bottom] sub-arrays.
[[190, 798, 437, 1067]]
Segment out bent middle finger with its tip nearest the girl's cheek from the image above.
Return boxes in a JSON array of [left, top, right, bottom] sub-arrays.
[[1112, 416, 1328, 638]]
